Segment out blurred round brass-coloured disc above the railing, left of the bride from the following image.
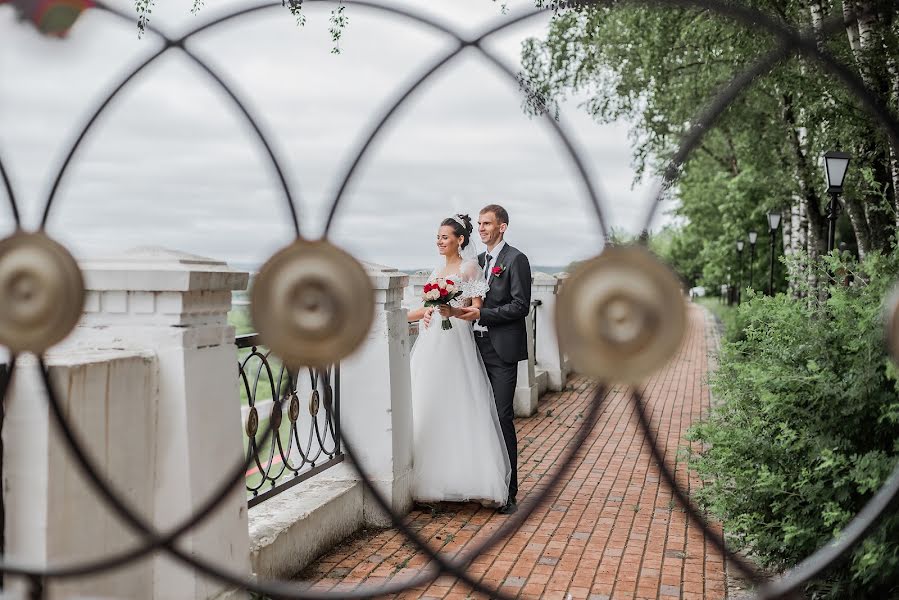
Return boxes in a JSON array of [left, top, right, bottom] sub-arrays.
[[250, 239, 374, 367]]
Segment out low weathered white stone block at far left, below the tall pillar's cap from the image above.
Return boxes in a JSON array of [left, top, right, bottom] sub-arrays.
[[2, 350, 157, 600]]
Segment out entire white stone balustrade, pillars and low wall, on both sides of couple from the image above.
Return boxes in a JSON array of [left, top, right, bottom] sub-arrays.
[[3, 248, 568, 600]]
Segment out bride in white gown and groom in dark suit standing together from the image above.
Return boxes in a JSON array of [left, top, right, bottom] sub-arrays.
[[408, 204, 531, 514]]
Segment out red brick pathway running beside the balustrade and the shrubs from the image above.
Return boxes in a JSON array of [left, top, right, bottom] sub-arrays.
[[301, 306, 727, 600]]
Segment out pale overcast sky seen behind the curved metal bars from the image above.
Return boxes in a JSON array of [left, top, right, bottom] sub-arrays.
[[0, 0, 676, 268]]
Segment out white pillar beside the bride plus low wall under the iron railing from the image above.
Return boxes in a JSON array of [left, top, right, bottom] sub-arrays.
[[250, 264, 414, 578]]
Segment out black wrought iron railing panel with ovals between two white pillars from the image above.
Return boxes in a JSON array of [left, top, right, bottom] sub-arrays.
[[235, 333, 344, 506]]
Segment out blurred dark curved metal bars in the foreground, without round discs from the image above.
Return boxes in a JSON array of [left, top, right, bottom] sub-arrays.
[[0, 0, 899, 598]]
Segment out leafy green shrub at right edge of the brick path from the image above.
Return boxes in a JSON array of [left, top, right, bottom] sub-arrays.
[[689, 247, 899, 599]]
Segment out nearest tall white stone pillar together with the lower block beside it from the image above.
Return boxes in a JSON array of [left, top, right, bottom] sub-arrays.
[[3, 248, 250, 600]]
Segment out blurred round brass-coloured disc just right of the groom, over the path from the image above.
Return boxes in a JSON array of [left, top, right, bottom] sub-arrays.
[[555, 246, 687, 384]]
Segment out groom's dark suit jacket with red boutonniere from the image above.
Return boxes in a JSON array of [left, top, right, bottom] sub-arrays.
[[478, 242, 531, 363]]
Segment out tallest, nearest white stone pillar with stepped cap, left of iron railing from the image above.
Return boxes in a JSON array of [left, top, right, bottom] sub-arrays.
[[69, 248, 250, 600]]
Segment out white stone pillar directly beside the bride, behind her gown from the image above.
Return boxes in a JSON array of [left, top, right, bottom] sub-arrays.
[[340, 263, 412, 525]]
